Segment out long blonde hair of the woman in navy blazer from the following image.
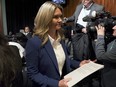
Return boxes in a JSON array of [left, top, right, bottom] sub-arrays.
[[34, 1, 64, 45]]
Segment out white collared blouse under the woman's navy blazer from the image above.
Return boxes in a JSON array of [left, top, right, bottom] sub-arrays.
[[48, 35, 65, 76]]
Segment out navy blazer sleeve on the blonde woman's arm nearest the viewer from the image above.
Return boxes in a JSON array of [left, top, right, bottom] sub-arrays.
[[25, 39, 58, 87]]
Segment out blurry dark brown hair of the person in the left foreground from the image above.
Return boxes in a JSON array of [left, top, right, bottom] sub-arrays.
[[0, 34, 22, 87]]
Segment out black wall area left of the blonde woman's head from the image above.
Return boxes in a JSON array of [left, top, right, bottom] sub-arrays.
[[6, 0, 45, 34]]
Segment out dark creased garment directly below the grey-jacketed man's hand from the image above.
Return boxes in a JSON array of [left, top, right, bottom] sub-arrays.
[[72, 33, 92, 61]]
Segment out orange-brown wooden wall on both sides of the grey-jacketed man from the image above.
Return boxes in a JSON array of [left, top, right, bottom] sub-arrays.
[[64, 0, 116, 17]]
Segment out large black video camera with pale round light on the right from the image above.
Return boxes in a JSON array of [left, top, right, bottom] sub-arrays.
[[83, 11, 116, 41]]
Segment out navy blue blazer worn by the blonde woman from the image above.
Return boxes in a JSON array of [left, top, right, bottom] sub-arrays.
[[26, 36, 80, 87]]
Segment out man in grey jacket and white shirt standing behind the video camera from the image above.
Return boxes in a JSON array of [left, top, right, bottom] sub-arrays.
[[66, 0, 104, 33]]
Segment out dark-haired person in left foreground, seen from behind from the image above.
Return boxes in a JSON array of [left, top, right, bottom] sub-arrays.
[[0, 34, 23, 87]]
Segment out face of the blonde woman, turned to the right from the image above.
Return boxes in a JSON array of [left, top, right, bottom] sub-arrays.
[[50, 8, 62, 30]]
